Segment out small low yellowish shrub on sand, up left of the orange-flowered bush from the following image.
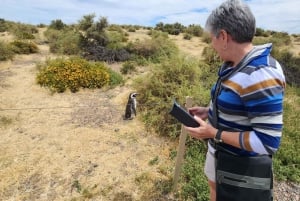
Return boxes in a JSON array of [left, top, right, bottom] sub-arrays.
[[10, 40, 39, 54]]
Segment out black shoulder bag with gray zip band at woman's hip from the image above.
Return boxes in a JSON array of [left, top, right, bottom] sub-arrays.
[[215, 145, 273, 201]]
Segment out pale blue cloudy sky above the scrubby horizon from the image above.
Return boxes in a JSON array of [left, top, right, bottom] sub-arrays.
[[0, 0, 300, 34]]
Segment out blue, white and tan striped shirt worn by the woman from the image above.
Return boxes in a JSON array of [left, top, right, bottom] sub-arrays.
[[209, 44, 285, 155]]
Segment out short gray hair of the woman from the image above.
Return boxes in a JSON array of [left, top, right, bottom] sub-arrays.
[[205, 0, 256, 43]]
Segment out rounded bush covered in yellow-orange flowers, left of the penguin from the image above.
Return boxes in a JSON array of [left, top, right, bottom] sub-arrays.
[[37, 57, 116, 92]]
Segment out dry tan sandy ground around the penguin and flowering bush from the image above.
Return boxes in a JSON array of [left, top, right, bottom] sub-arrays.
[[0, 45, 175, 201]]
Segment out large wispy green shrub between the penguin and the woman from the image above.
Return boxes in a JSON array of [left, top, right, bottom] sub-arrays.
[[135, 55, 209, 137]]
